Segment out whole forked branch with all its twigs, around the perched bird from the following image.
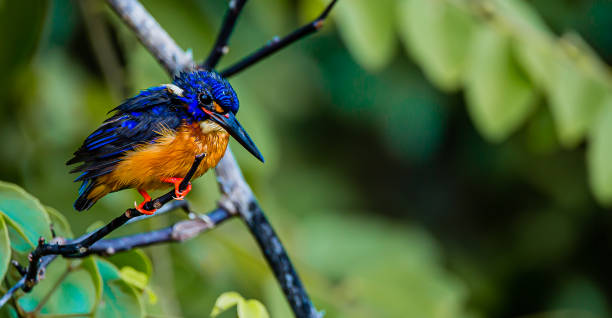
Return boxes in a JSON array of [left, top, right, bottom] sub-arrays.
[[0, 0, 335, 318]]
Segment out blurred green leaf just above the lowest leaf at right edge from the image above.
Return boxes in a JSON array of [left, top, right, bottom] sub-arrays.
[[548, 52, 610, 147]]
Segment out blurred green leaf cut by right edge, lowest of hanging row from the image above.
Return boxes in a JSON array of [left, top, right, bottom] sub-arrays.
[[587, 97, 612, 206]]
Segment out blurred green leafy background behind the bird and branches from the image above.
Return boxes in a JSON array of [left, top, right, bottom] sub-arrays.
[[0, 0, 612, 318]]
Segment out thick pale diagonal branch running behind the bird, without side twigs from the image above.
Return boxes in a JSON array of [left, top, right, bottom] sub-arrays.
[[107, 0, 322, 318]]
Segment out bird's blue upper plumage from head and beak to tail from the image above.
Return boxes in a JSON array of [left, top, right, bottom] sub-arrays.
[[67, 71, 262, 211]]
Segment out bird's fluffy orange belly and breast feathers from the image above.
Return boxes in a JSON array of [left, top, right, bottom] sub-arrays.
[[88, 124, 229, 200]]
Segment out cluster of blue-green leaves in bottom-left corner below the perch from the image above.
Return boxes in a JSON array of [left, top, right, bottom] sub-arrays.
[[0, 182, 151, 317]]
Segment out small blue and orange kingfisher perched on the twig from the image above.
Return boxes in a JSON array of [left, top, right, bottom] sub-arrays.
[[66, 70, 264, 215]]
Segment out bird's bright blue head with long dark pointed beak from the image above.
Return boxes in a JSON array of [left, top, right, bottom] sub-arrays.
[[169, 71, 263, 162]]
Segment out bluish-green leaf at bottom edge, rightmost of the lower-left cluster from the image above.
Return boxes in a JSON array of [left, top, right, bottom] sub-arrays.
[[95, 259, 144, 318]]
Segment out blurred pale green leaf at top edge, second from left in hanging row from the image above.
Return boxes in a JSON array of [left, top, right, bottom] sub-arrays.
[[398, 0, 475, 91]]
